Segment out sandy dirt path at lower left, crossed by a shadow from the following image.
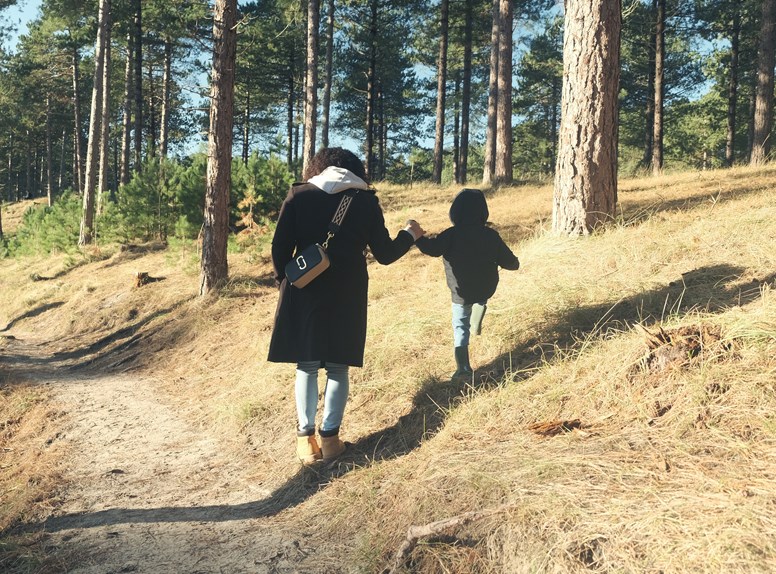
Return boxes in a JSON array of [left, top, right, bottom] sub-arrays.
[[3, 341, 332, 574]]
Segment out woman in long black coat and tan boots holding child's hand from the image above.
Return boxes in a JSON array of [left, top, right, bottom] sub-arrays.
[[268, 148, 424, 464]]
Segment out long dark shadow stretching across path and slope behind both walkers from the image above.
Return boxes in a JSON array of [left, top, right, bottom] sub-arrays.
[[23, 265, 776, 532]]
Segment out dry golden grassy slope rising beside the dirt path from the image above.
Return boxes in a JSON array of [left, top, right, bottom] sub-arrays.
[[0, 167, 776, 572]]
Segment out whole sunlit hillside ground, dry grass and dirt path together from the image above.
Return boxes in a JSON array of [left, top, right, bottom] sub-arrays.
[[0, 167, 776, 573]]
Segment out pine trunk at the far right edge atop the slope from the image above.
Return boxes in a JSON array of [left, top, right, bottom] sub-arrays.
[[750, 0, 776, 165]]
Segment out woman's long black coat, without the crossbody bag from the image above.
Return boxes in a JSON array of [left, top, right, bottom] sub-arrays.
[[268, 184, 413, 367]]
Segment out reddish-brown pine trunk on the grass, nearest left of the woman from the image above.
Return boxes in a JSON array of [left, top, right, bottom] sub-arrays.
[[199, 0, 237, 295]]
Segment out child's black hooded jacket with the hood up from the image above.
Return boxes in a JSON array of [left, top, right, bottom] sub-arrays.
[[415, 189, 520, 305]]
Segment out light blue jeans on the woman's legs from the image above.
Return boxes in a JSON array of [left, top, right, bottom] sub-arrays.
[[295, 361, 350, 432]]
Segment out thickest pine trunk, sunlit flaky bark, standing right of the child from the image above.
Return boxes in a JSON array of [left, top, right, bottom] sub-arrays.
[[552, 0, 622, 235]]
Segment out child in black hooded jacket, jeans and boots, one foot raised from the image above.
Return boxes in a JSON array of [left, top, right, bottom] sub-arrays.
[[415, 189, 520, 378]]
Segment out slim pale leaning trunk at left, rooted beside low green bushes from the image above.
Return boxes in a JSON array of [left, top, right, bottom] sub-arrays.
[[78, 0, 110, 246]]
